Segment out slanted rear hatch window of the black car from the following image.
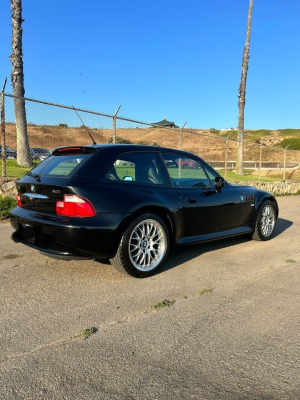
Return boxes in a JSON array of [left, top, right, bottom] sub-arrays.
[[30, 154, 92, 177]]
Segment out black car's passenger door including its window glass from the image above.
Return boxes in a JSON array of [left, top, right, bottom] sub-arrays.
[[162, 153, 240, 236]]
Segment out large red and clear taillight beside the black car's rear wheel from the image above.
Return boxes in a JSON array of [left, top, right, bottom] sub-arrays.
[[56, 194, 96, 218]]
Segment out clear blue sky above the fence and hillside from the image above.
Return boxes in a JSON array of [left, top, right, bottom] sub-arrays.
[[0, 0, 300, 129]]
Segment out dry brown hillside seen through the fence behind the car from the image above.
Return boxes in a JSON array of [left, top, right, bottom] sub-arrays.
[[2, 124, 300, 162]]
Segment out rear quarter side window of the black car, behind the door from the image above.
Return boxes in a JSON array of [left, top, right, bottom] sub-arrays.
[[104, 152, 167, 185]]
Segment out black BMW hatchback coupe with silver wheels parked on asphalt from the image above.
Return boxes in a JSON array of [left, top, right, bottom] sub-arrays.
[[10, 145, 278, 277]]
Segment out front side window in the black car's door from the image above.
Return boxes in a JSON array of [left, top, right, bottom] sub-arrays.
[[162, 153, 212, 189]]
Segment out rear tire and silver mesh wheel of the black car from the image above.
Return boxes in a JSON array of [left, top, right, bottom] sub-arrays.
[[110, 213, 170, 278]]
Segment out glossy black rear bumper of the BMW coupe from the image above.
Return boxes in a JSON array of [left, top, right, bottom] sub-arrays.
[[10, 207, 128, 260]]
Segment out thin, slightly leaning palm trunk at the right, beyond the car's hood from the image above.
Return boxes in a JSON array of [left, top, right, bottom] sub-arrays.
[[236, 0, 253, 175]]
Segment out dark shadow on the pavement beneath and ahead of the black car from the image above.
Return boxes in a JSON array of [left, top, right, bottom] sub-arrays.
[[157, 218, 293, 274]]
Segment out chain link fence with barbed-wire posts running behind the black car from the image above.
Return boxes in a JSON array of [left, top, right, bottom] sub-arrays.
[[0, 93, 300, 181]]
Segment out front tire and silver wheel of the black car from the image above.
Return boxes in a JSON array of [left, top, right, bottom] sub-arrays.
[[251, 200, 276, 241]]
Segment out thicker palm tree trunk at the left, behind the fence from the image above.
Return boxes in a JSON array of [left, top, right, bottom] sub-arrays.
[[10, 0, 31, 167]]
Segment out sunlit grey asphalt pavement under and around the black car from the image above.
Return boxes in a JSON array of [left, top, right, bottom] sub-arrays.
[[0, 196, 300, 400]]
